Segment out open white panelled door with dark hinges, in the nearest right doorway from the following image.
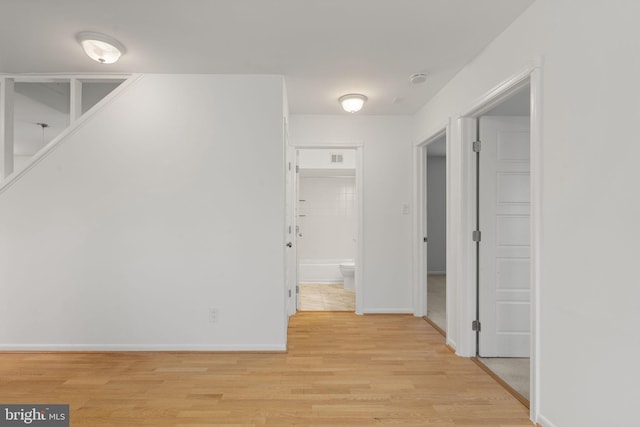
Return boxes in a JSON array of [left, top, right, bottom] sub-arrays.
[[479, 117, 531, 357]]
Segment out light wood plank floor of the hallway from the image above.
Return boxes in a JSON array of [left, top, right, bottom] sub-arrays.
[[0, 312, 531, 427]]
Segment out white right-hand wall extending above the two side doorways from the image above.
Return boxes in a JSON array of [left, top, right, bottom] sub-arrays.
[[415, 0, 640, 427]]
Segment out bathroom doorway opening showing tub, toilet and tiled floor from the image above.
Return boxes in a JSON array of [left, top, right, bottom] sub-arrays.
[[295, 147, 360, 312]]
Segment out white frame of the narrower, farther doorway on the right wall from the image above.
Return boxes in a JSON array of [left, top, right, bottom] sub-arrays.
[[413, 120, 455, 348]]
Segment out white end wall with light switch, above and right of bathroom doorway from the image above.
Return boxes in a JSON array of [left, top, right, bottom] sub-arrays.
[[291, 115, 413, 313]]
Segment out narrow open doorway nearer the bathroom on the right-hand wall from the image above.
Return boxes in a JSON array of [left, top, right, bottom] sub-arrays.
[[425, 135, 447, 336]]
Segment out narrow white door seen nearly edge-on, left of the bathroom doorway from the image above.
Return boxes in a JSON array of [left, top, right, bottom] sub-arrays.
[[284, 145, 298, 315]]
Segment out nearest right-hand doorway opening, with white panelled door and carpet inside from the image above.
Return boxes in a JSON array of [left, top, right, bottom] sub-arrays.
[[474, 85, 532, 404]]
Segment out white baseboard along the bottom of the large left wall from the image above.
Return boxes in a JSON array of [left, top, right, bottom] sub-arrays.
[[0, 344, 287, 352]]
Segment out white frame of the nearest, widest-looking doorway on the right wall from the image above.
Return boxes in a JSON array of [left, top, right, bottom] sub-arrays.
[[455, 59, 543, 420]]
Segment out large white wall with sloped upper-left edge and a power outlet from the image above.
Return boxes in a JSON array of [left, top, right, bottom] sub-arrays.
[[0, 75, 286, 350]]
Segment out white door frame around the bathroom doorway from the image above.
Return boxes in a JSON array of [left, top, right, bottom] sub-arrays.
[[287, 142, 365, 315]]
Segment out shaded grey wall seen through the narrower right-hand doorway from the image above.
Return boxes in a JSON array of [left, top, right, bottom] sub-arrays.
[[427, 156, 447, 274]]
